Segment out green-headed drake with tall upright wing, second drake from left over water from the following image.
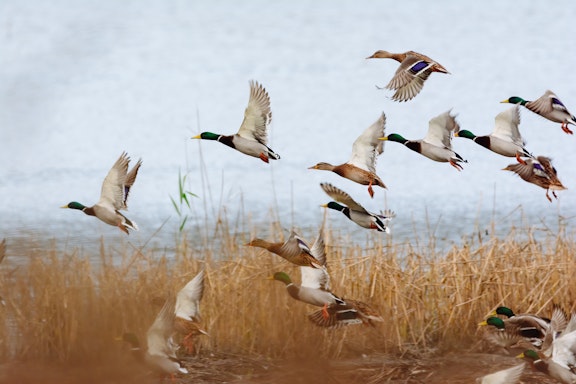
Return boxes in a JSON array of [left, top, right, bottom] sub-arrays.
[[192, 81, 280, 163]]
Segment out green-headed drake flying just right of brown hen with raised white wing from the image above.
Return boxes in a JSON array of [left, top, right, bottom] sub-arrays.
[[380, 111, 468, 171]]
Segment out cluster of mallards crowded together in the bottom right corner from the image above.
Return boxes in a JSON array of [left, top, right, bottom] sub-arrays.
[[479, 306, 576, 384]]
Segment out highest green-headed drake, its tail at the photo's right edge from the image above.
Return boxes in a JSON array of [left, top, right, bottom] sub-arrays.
[[502, 90, 576, 135]]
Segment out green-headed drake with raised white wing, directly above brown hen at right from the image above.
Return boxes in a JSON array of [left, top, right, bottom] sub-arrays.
[[454, 106, 533, 163]]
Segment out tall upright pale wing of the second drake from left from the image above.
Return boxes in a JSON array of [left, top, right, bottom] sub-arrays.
[[238, 81, 272, 145]]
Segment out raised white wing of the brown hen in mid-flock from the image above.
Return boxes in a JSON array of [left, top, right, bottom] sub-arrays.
[[348, 113, 386, 173]]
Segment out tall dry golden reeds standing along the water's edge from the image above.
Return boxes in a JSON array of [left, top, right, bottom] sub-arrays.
[[0, 216, 576, 361]]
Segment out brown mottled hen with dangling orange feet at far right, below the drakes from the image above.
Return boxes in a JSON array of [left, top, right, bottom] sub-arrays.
[[504, 156, 566, 202]]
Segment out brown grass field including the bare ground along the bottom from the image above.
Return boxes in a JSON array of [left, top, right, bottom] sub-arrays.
[[0, 218, 576, 383]]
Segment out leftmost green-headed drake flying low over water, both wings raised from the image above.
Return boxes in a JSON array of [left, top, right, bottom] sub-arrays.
[[62, 152, 142, 234]]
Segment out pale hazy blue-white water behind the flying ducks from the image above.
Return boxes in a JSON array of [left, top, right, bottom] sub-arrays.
[[0, 0, 576, 255]]
